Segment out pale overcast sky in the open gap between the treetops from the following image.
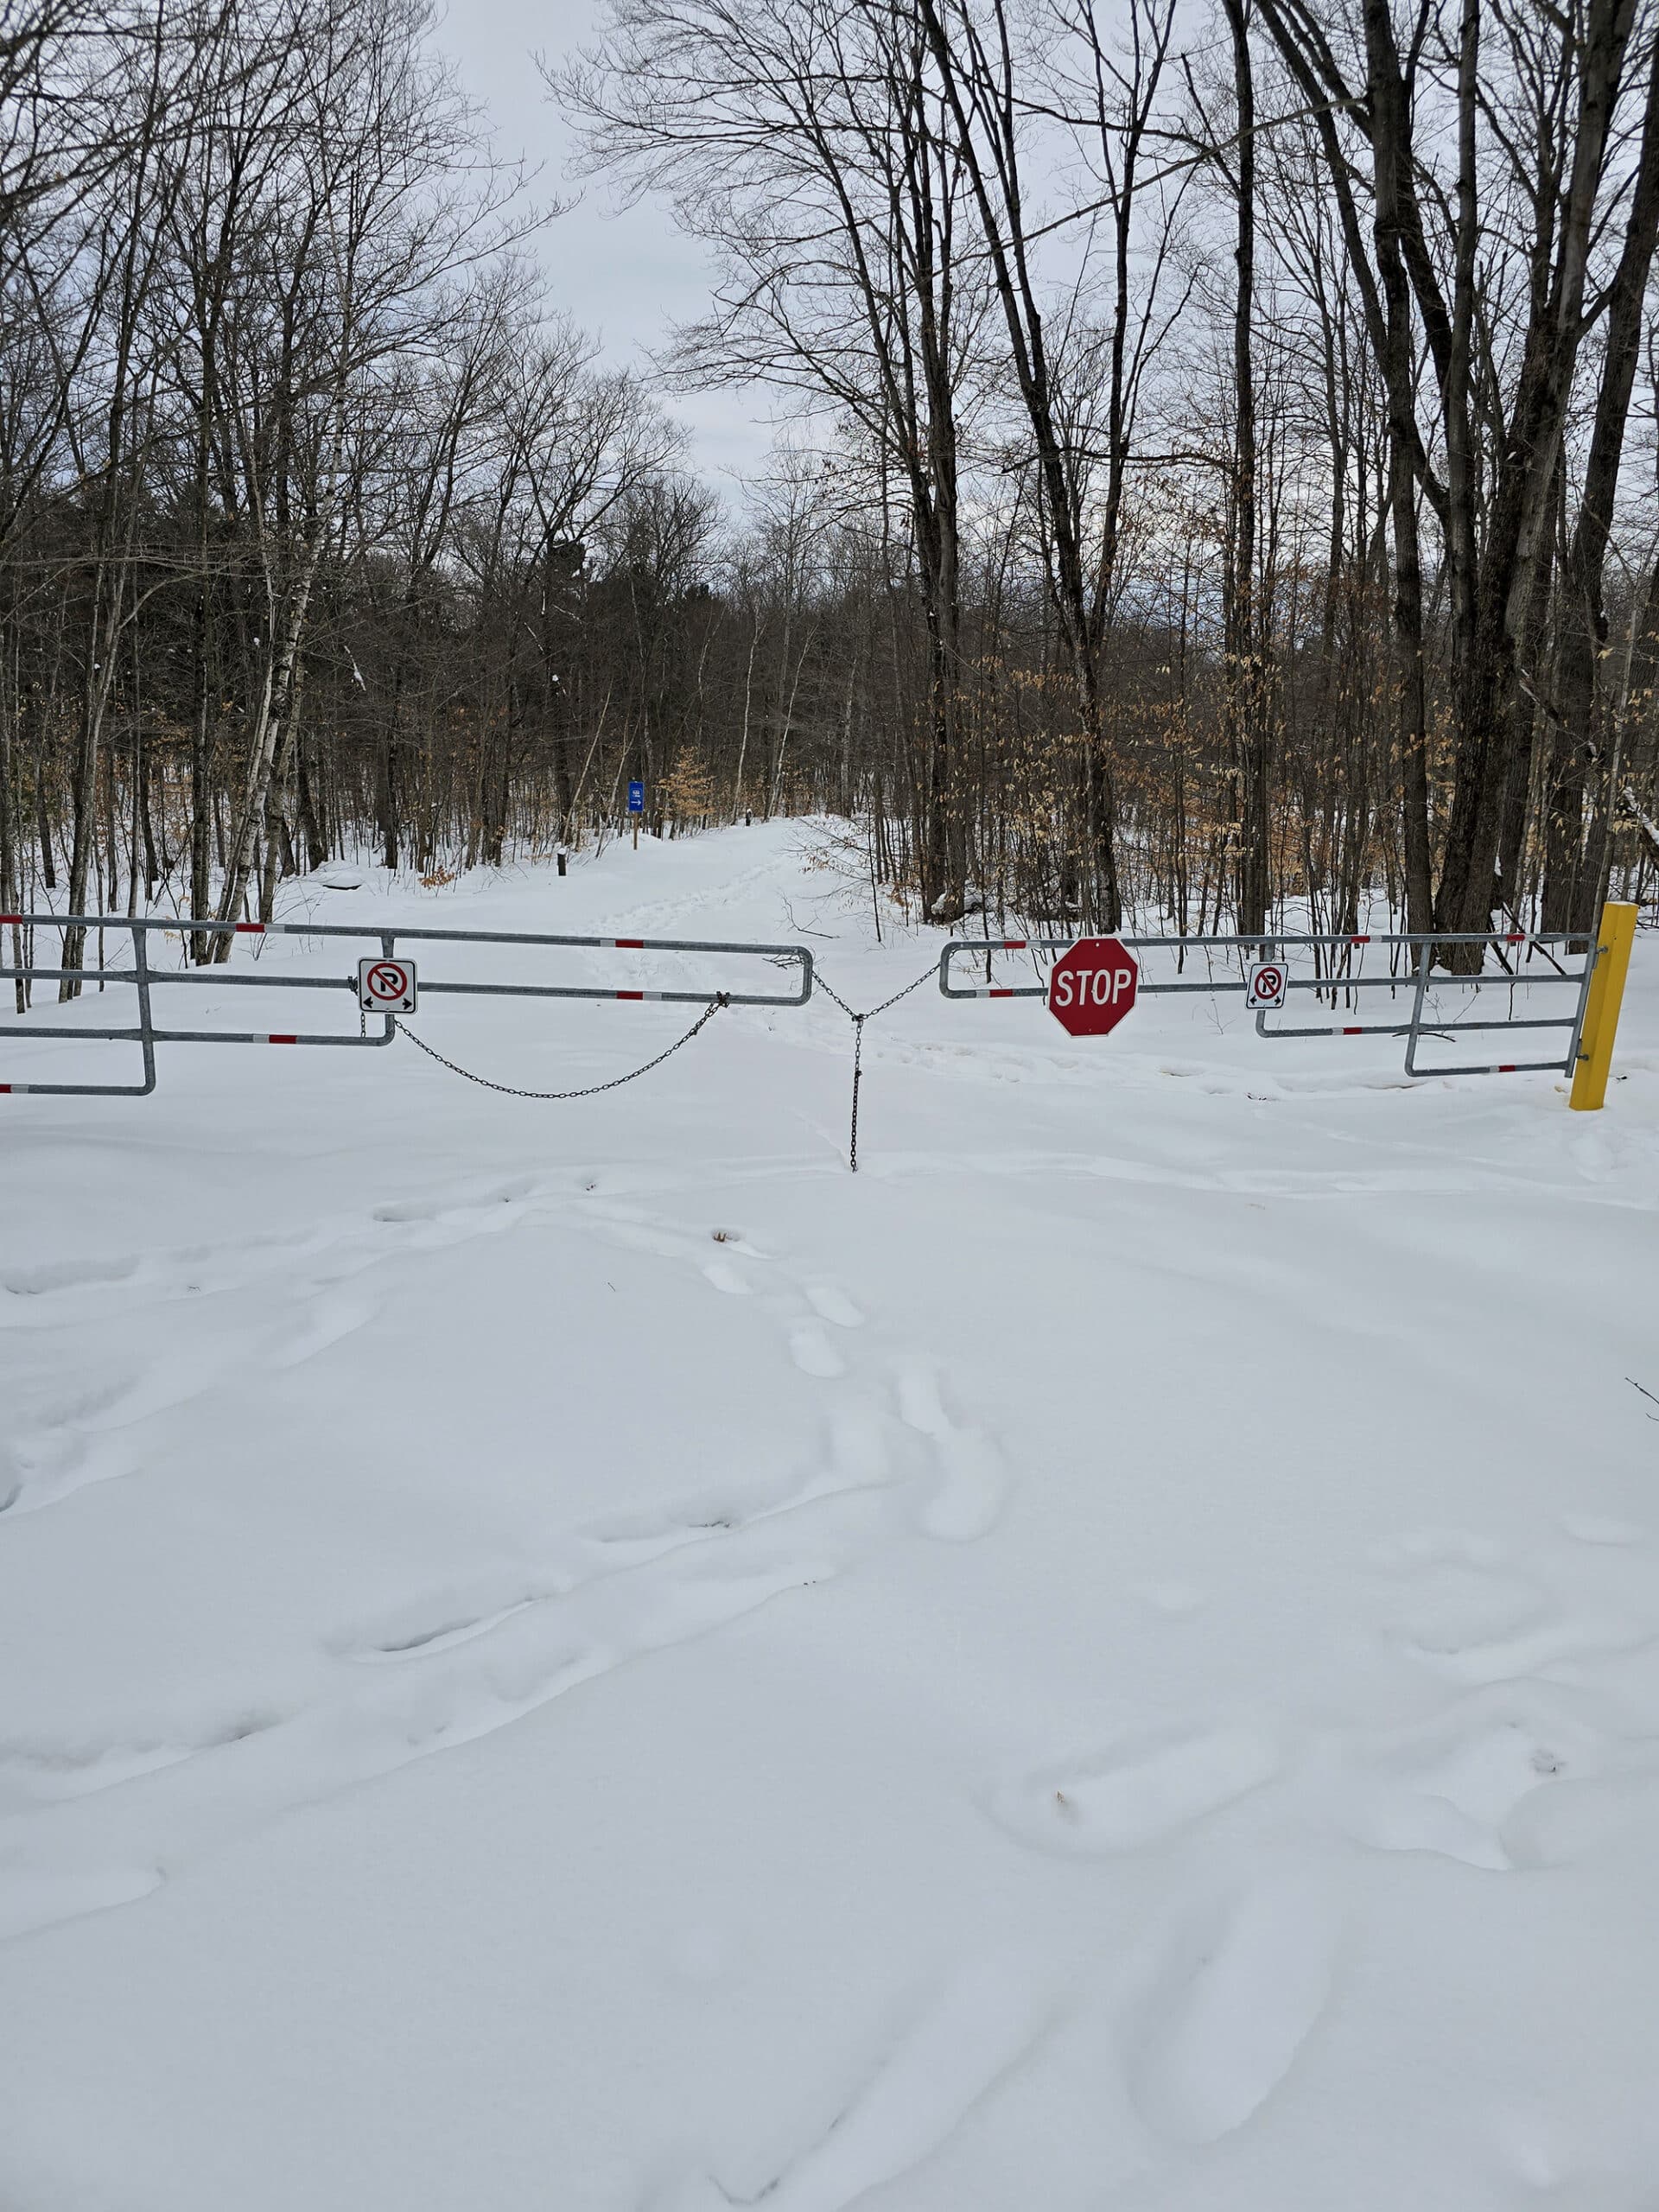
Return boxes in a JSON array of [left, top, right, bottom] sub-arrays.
[[435, 0, 770, 495]]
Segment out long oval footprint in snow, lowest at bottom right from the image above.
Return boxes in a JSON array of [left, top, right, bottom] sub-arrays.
[[1128, 1867, 1338, 2144]]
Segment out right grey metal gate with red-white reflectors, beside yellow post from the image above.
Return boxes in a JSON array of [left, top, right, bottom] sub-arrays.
[[938, 929, 1597, 1077]]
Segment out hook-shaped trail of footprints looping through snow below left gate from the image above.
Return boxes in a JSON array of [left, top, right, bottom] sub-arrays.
[[0, 1181, 1004, 1924]]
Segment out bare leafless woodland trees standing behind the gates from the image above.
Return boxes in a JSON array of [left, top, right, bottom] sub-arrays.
[[0, 0, 1659, 988]]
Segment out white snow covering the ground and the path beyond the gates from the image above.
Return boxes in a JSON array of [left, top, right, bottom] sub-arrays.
[[0, 825, 1659, 2212]]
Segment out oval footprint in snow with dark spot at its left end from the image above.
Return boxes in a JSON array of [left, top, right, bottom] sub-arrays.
[[991, 1723, 1283, 1853]]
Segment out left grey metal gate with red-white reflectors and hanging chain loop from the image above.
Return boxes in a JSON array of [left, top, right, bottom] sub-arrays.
[[0, 913, 812, 1097]]
